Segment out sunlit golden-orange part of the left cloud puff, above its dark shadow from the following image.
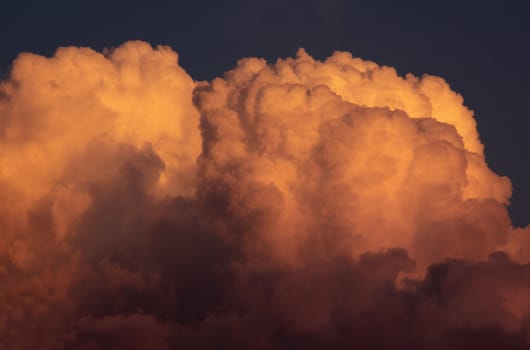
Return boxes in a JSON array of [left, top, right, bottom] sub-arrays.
[[0, 42, 201, 241]]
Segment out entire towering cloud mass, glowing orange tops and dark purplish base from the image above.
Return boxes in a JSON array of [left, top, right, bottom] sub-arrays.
[[0, 41, 530, 350]]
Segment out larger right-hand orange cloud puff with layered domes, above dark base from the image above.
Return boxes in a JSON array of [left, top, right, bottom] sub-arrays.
[[195, 51, 511, 265]]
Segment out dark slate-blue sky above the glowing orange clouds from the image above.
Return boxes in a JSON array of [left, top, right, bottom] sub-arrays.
[[0, 0, 530, 225]]
